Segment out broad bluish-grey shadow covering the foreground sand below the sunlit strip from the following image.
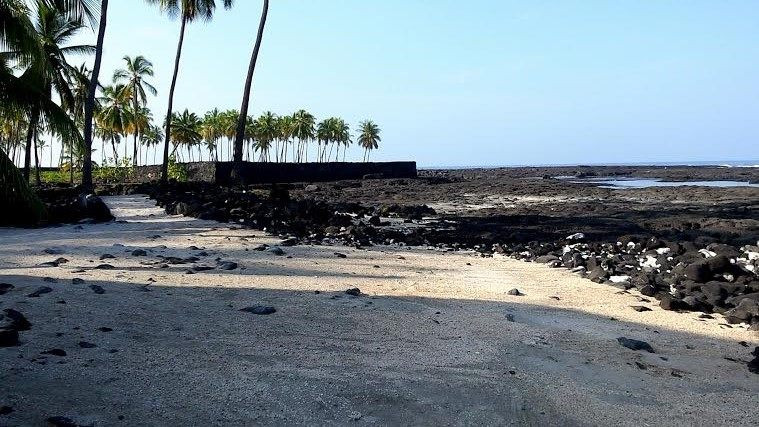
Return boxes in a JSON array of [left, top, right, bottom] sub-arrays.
[[0, 270, 759, 425]]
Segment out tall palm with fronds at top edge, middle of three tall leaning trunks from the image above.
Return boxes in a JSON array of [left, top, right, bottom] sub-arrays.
[[147, 0, 233, 182]]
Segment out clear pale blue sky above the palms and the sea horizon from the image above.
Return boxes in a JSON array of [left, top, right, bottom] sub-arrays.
[[71, 0, 759, 166]]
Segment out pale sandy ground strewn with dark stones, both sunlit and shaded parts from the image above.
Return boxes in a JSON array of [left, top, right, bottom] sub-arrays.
[[0, 196, 759, 425]]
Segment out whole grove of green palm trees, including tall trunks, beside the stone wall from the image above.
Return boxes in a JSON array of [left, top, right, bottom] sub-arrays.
[[0, 0, 380, 191]]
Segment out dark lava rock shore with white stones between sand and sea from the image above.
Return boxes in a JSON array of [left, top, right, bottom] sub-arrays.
[[99, 164, 759, 330]]
